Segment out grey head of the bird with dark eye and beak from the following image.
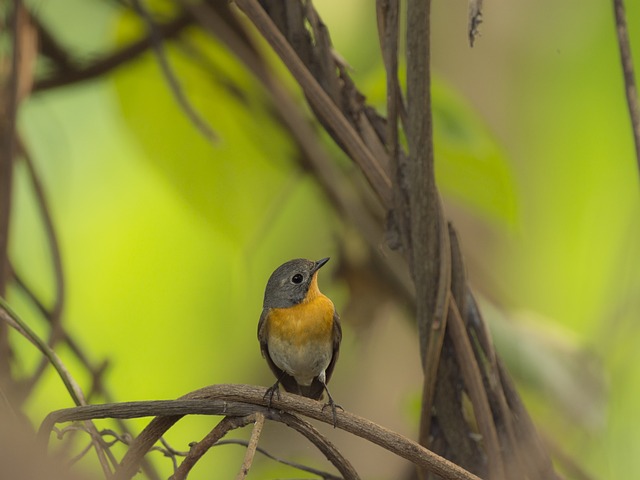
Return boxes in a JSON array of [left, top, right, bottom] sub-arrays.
[[263, 258, 329, 308]]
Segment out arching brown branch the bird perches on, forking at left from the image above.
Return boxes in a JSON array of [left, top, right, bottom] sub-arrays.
[[38, 385, 478, 480]]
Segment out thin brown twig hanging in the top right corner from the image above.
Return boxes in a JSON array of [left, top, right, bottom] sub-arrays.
[[613, 0, 640, 173]]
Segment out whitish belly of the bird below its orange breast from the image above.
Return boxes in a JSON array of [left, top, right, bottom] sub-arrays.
[[268, 335, 333, 386]]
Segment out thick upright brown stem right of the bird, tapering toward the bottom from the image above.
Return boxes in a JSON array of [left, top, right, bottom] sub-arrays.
[[399, 0, 451, 472]]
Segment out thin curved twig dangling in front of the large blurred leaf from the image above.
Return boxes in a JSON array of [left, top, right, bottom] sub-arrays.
[[132, 0, 218, 142]]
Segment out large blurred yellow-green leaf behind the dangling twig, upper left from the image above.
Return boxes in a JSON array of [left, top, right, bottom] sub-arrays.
[[113, 15, 295, 243]]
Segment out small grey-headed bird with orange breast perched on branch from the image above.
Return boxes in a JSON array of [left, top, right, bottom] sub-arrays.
[[258, 258, 342, 427]]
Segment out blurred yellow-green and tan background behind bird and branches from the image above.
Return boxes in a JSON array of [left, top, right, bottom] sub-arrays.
[[8, 0, 640, 479]]
